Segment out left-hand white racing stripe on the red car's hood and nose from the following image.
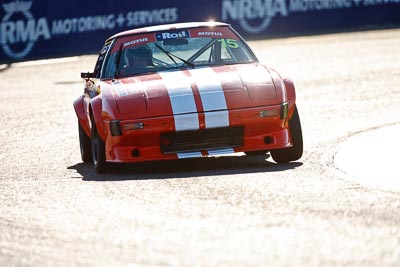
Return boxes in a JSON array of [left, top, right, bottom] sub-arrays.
[[159, 71, 200, 131]]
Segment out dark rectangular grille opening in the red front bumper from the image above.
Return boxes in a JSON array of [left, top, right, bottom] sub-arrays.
[[160, 127, 244, 154]]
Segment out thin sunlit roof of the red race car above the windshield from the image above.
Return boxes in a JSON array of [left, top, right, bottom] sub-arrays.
[[107, 21, 229, 41]]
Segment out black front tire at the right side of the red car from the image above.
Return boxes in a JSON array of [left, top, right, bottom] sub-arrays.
[[271, 106, 303, 163]]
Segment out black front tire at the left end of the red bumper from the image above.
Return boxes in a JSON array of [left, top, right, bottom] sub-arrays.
[[91, 118, 110, 173]]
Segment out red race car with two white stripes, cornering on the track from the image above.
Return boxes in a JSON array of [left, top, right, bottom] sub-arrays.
[[74, 22, 303, 172]]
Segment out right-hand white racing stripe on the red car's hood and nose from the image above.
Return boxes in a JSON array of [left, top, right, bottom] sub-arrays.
[[190, 68, 229, 128]]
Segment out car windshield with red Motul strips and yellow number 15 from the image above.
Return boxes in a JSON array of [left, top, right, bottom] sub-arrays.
[[101, 27, 257, 78]]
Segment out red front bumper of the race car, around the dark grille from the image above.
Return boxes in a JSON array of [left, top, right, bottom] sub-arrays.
[[105, 105, 291, 162]]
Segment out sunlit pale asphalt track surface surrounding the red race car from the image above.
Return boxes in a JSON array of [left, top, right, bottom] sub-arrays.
[[0, 29, 400, 267]]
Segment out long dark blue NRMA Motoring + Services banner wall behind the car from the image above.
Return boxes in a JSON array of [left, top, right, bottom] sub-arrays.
[[0, 0, 400, 63]]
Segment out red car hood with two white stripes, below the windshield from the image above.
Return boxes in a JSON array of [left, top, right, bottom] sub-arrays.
[[108, 64, 279, 118]]
